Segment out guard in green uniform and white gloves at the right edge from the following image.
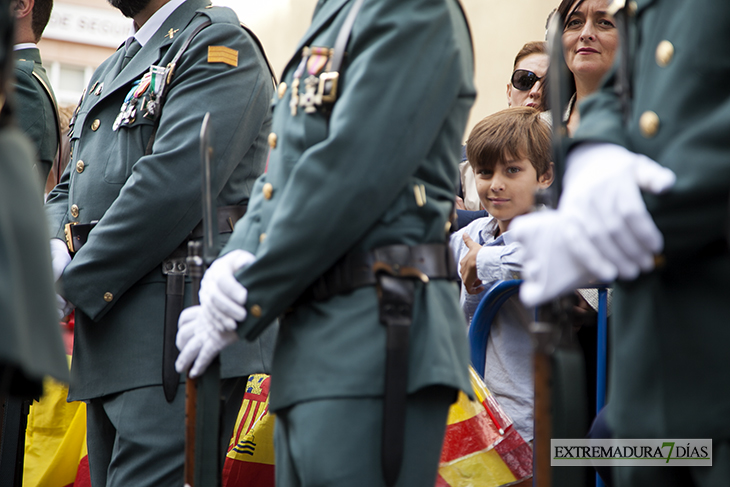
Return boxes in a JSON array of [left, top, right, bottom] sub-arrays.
[[515, 0, 730, 486]]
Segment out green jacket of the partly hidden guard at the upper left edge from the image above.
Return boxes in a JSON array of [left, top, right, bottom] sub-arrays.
[[15, 49, 60, 188]]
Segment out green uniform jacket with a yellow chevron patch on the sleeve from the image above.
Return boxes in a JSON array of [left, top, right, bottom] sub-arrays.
[[46, 0, 275, 400]]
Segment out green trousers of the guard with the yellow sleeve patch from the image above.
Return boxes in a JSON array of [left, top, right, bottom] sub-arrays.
[[86, 377, 247, 487]]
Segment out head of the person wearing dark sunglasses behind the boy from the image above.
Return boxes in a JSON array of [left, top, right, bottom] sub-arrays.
[[507, 42, 550, 111]]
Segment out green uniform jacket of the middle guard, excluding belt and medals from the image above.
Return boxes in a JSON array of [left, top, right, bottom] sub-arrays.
[[224, 0, 475, 410]]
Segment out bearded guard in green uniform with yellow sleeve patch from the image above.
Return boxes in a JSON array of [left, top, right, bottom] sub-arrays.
[[46, 0, 276, 487]]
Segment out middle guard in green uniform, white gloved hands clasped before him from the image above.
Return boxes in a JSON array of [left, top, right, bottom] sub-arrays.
[[178, 0, 475, 487]]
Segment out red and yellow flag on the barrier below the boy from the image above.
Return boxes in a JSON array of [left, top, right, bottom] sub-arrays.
[[436, 367, 532, 487]]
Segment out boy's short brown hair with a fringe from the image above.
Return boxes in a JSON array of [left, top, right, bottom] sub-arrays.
[[466, 107, 552, 177]]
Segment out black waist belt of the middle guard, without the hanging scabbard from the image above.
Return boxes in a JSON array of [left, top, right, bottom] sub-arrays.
[[300, 243, 457, 303]]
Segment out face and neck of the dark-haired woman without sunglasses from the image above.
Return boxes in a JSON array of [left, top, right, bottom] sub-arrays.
[[558, 0, 618, 135]]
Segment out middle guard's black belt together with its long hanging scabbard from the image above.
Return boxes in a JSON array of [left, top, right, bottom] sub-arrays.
[[300, 244, 456, 487]]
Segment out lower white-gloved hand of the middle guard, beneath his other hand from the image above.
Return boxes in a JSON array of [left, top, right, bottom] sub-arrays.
[[175, 306, 238, 378]]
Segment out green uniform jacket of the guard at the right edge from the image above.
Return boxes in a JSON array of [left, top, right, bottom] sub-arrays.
[[576, 0, 730, 440]]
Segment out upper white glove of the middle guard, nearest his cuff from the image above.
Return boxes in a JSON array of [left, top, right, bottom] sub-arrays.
[[199, 250, 256, 332]]
